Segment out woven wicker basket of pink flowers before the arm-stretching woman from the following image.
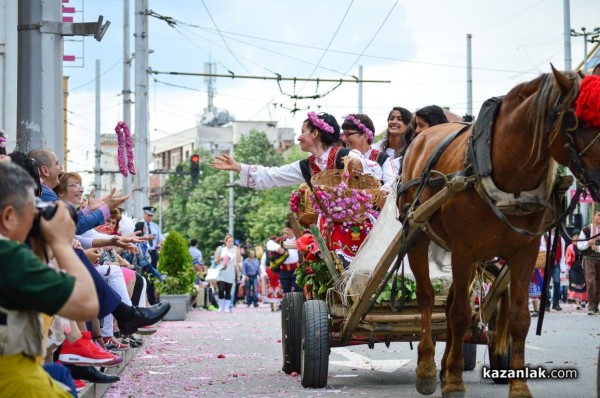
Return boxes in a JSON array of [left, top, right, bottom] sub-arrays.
[[311, 159, 381, 223]]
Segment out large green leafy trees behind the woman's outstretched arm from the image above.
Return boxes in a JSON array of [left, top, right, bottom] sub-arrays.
[[164, 130, 306, 255]]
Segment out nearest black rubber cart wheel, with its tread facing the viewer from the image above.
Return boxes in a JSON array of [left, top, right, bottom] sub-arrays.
[[301, 300, 331, 388]]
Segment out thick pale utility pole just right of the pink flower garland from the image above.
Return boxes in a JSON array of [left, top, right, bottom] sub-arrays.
[[133, 0, 150, 218]]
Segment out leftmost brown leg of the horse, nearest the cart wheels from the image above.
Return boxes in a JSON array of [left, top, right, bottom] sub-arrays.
[[408, 237, 437, 395]]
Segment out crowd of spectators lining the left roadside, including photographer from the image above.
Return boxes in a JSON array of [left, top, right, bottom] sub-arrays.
[[0, 149, 170, 397]]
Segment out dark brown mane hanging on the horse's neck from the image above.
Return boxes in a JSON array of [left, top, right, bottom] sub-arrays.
[[527, 71, 581, 163]]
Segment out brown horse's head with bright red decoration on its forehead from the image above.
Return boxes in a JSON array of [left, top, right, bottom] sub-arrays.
[[552, 67, 600, 202]]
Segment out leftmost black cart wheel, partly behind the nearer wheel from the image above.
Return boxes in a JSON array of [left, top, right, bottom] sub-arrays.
[[281, 292, 306, 374]]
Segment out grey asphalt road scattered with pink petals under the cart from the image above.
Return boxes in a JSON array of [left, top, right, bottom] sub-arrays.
[[105, 305, 600, 398]]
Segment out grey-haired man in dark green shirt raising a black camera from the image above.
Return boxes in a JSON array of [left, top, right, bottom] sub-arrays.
[[0, 162, 98, 397]]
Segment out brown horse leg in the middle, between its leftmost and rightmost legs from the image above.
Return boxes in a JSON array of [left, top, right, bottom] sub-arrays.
[[442, 252, 475, 398]]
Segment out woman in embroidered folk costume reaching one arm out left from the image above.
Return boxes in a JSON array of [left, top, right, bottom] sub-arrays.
[[211, 112, 383, 266]]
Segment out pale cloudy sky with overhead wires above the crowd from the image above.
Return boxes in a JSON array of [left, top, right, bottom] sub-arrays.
[[64, 0, 600, 174]]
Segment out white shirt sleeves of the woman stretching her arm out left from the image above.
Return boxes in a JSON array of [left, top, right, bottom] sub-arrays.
[[237, 147, 383, 189]]
